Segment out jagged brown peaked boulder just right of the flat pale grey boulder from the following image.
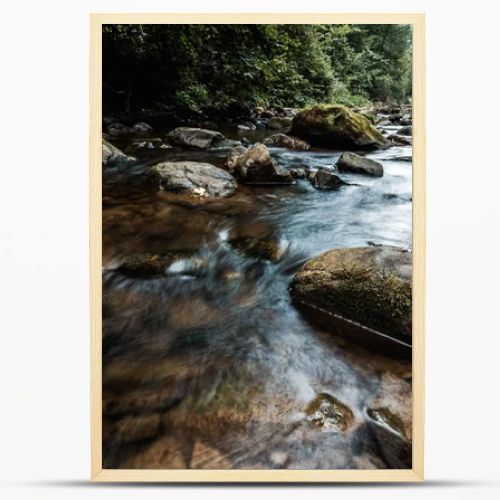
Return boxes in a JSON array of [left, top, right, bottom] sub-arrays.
[[227, 144, 295, 184]]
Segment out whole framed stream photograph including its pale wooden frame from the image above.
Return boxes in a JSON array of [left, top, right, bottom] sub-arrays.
[[90, 14, 425, 482]]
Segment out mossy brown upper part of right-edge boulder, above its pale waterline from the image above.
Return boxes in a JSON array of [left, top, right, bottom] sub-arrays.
[[291, 246, 412, 340]]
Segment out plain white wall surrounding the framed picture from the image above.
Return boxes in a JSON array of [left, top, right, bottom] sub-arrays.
[[0, 0, 500, 500]]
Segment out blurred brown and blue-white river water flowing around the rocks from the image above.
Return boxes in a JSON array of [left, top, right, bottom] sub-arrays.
[[103, 125, 412, 469]]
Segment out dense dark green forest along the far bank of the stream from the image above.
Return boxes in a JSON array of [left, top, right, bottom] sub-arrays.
[[103, 24, 412, 116]]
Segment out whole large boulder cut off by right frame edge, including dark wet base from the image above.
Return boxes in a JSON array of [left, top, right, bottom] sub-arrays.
[[290, 245, 412, 357]]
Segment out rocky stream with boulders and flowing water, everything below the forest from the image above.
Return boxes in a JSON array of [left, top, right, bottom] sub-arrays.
[[103, 103, 412, 469]]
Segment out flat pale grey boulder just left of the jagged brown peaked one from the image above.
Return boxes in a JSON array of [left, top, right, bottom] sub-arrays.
[[151, 161, 237, 197]]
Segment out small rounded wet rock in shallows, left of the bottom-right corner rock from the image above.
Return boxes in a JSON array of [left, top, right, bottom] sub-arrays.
[[305, 393, 354, 432]]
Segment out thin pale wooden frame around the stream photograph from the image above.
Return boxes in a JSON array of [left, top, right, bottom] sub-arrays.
[[89, 13, 426, 482]]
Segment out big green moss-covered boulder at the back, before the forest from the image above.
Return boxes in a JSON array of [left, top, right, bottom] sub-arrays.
[[291, 104, 390, 150]]
